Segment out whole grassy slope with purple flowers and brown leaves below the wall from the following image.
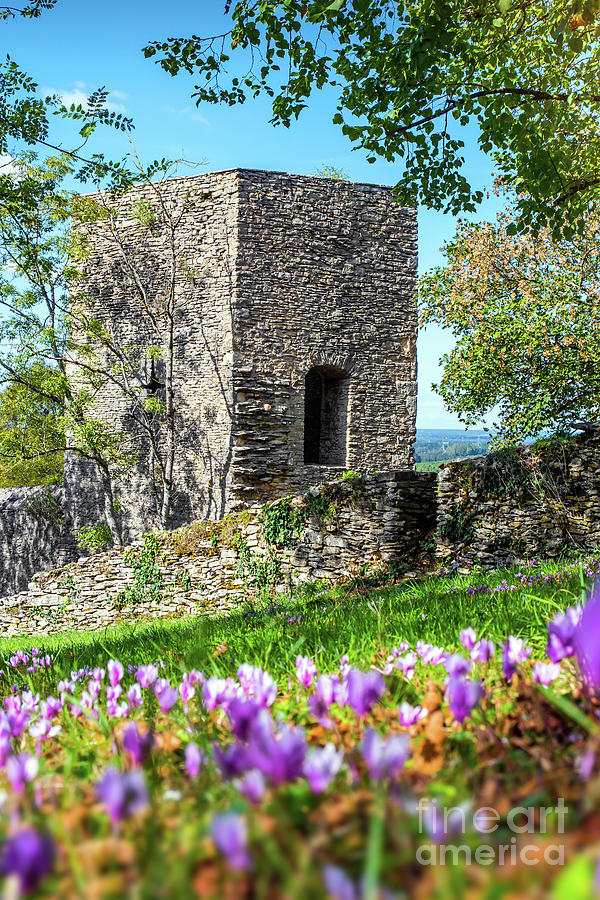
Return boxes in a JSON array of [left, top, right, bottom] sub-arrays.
[[0, 557, 600, 900]]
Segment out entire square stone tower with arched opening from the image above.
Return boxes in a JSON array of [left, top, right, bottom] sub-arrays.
[[65, 169, 417, 537]]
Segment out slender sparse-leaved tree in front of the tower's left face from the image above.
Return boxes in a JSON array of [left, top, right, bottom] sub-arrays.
[[0, 151, 202, 540]]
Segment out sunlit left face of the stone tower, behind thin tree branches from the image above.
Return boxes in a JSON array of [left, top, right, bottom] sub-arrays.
[[65, 172, 239, 542]]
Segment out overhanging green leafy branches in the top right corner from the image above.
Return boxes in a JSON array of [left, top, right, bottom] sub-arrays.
[[144, 0, 600, 234]]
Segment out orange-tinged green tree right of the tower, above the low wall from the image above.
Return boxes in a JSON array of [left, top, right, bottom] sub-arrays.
[[419, 202, 600, 442]]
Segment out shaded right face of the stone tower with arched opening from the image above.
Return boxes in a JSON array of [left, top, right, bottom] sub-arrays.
[[231, 171, 417, 505]]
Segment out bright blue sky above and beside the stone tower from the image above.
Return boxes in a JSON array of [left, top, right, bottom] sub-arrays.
[[0, 0, 497, 428]]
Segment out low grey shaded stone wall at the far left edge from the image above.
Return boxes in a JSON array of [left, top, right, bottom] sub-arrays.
[[0, 487, 80, 597]]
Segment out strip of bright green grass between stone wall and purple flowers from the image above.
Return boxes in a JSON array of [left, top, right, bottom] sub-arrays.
[[0, 560, 597, 692]]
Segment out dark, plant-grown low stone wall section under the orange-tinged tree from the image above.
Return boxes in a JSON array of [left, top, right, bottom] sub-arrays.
[[437, 429, 600, 571]]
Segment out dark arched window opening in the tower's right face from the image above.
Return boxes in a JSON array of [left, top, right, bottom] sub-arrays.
[[304, 366, 350, 466]]
